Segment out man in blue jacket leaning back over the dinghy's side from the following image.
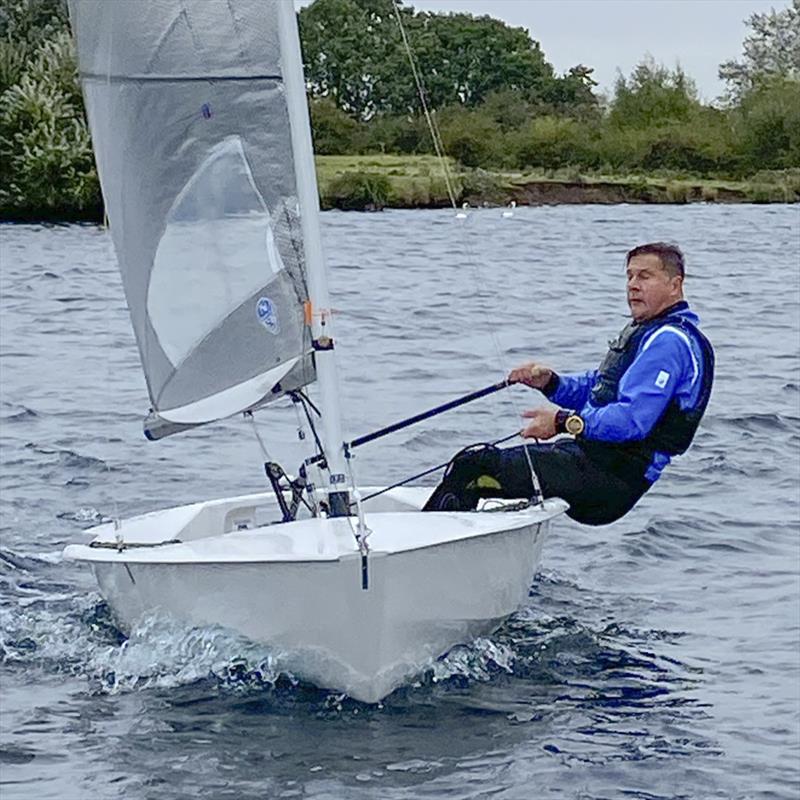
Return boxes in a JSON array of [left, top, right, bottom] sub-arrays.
[[425, 242, 714, 525]]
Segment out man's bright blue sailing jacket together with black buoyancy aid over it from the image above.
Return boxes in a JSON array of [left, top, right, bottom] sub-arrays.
[[546, 301, 714, 483]]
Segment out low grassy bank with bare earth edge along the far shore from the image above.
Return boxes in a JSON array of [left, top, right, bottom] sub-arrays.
[[317, 155, 800, 210]]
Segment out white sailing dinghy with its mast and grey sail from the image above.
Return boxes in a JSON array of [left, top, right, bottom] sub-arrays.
[[64, 0, 566, 702]]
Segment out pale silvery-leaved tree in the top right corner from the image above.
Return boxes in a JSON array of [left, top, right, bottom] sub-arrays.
[[719, 0, 800, 104]]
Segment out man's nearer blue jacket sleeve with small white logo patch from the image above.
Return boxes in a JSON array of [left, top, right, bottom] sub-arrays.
[[580, 331, 700, 442]]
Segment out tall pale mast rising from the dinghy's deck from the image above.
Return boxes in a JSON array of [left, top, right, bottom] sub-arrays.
[[276, 0, 350, 517]]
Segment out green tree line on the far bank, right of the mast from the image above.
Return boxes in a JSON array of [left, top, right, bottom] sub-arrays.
[[299, 0, 800, 177]]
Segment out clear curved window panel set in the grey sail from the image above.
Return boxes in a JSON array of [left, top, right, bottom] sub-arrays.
[[147, 136, 284, 366]]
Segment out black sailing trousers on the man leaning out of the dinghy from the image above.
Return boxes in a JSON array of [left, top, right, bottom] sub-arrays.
[[423, 439, 651, 525]]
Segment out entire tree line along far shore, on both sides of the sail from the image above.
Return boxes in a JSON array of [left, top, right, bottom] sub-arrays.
[[0, 0, 800, 218]]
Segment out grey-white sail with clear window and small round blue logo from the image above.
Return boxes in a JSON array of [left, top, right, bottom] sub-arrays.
[[69, 0, 317, 430]]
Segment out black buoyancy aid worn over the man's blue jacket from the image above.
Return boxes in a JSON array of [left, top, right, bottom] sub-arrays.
[[582, 301, 714, 478]]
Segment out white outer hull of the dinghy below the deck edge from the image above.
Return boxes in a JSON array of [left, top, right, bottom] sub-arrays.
[[93, 523, 544, 702]]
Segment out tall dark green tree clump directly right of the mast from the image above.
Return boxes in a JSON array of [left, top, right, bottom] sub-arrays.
[[299, 0, 568, 119]]
